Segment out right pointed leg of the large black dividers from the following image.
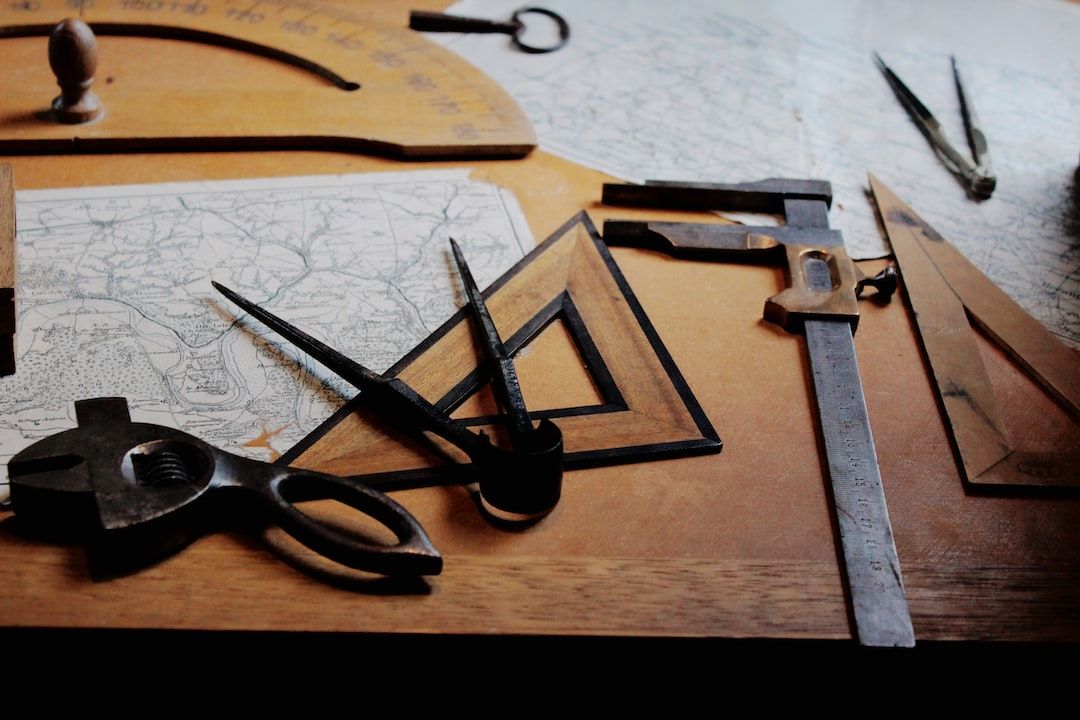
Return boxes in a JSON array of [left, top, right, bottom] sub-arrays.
[[450, 237, 532, 436]]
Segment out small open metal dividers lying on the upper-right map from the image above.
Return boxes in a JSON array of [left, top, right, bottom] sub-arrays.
[[874, 53, 998, 200]]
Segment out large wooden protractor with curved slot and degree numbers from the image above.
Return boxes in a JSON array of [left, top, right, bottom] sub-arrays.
[[0, 0, 536, 158]]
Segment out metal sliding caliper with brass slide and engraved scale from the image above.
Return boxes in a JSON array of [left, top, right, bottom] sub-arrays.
[[604, 179, 915, 647]]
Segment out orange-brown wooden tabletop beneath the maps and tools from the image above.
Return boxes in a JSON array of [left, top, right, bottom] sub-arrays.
[[0, 3, 1080, 641]]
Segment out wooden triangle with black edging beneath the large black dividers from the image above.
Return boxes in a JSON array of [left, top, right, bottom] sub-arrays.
[[279, 213, 721, 488]]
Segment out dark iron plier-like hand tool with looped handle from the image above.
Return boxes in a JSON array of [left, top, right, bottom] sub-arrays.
[[8, 397, 443, 575]]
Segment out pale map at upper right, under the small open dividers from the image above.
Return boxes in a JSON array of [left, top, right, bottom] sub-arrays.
[[428, 0, 1080, 347]]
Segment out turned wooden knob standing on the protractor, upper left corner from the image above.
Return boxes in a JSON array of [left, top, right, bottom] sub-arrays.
[[49, 17, 105, 124]]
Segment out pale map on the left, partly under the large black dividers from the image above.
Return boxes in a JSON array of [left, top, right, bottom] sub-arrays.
[[0, 171, 535, 499]]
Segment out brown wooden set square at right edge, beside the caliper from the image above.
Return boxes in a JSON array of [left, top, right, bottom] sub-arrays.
[[869, 175, 1080, 488]]
